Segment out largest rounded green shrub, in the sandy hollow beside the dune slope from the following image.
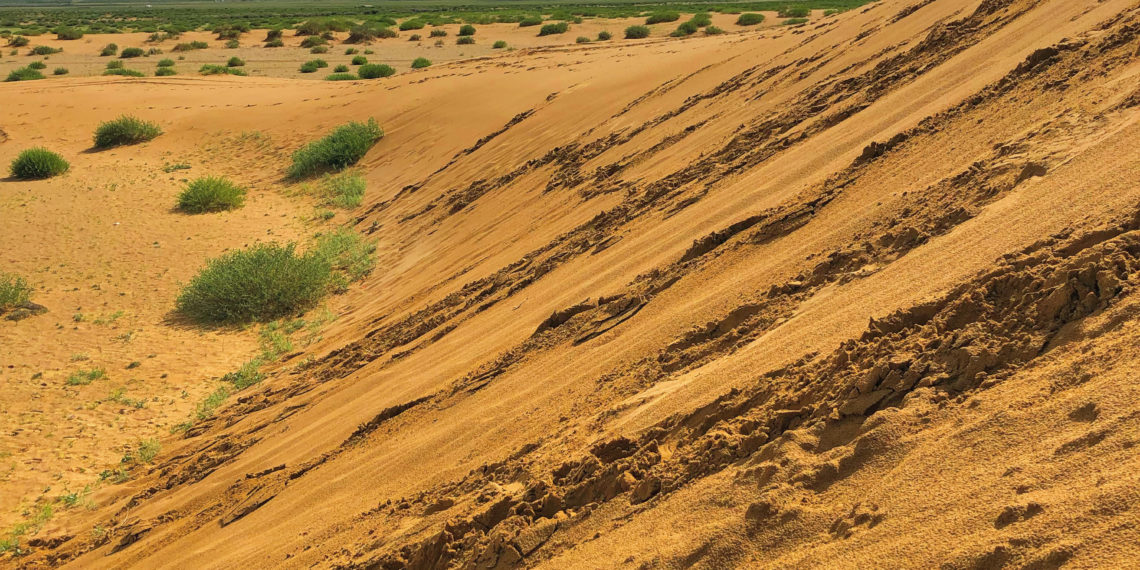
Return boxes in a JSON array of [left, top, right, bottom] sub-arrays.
[[176, 243, 332, 323]]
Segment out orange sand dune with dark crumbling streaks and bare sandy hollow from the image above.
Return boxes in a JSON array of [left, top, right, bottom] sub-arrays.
[[0, 0, 1140, 569]]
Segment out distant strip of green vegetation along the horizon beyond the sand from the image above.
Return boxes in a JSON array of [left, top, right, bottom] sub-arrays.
[[0, 0, 873, 35]]
